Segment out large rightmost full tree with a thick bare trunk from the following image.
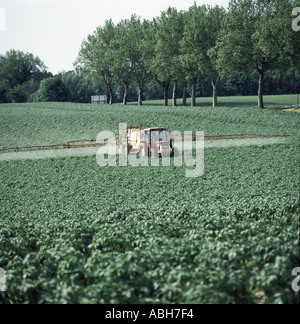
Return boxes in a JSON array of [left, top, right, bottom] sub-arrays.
[[217, 0, 299, 108]]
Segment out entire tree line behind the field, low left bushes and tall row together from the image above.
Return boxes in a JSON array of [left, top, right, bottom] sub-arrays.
[[0, 0, 300, 108]]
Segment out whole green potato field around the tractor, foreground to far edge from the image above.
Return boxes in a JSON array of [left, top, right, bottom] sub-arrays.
[[0, 99, 300, 304]]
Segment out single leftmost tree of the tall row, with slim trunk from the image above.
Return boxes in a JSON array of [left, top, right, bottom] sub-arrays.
[[75, 20, 117, 104]]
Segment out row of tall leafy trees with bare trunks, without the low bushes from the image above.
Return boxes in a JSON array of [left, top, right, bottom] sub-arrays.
[[75, 0, 300, 108]]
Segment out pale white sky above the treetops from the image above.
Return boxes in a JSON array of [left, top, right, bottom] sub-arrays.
[[0, 0, 229, 74]]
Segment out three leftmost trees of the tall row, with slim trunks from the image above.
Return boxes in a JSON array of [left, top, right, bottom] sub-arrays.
[[75, 15, 152, 104]]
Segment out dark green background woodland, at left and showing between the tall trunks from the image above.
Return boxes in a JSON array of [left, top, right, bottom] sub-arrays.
[[0, 50, 300, 103]]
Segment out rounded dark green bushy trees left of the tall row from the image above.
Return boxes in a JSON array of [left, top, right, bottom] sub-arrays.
[[0, 50, 101, 103]]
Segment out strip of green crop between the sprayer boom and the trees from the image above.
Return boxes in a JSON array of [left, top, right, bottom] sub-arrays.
[[0, 96, 300, 149]]
